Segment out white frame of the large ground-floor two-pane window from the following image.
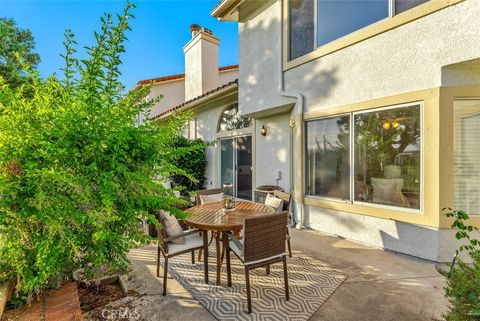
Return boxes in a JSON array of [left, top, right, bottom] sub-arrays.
[[303, 101, 425, 214]]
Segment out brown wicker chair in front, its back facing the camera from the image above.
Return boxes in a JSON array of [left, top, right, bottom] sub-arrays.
[[224, 212, 290, 313]]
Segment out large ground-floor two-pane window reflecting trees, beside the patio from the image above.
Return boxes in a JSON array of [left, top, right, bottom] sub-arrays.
[[306, 104, 422, 209]]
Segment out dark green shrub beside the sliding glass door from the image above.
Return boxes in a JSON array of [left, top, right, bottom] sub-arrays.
[[172, 135, 211, 195]]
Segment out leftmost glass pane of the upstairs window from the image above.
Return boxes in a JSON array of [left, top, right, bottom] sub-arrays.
[[289, 0, 315, 60]]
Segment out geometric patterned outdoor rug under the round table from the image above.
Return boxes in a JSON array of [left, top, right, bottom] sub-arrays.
[[165, 246, 346, 321]]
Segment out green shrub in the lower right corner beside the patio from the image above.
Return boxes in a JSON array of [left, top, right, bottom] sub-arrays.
[[445, 209, 480, 321]]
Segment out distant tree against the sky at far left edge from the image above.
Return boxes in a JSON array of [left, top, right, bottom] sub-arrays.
[[0, 17, 40, 88]]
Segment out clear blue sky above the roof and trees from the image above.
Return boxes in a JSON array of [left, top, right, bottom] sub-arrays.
[[0, 0, 238, 88]]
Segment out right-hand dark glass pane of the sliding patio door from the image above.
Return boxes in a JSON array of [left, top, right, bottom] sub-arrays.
[[237, 136, 252, 200]]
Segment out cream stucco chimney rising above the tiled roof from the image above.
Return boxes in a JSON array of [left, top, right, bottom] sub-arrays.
[[183, 24, 220, 101]]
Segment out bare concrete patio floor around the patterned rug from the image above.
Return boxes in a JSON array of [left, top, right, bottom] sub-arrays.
[[86, 230, 448, 321]]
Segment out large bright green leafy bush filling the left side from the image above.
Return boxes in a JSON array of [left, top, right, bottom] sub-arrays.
[[0, 3, 192, 301]]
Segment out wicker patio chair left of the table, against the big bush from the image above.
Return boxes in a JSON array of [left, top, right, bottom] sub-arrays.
[[157, 212, 208, 296]]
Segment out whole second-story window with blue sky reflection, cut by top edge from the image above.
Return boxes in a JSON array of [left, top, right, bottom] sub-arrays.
[[289, 0, 429, 60]]
